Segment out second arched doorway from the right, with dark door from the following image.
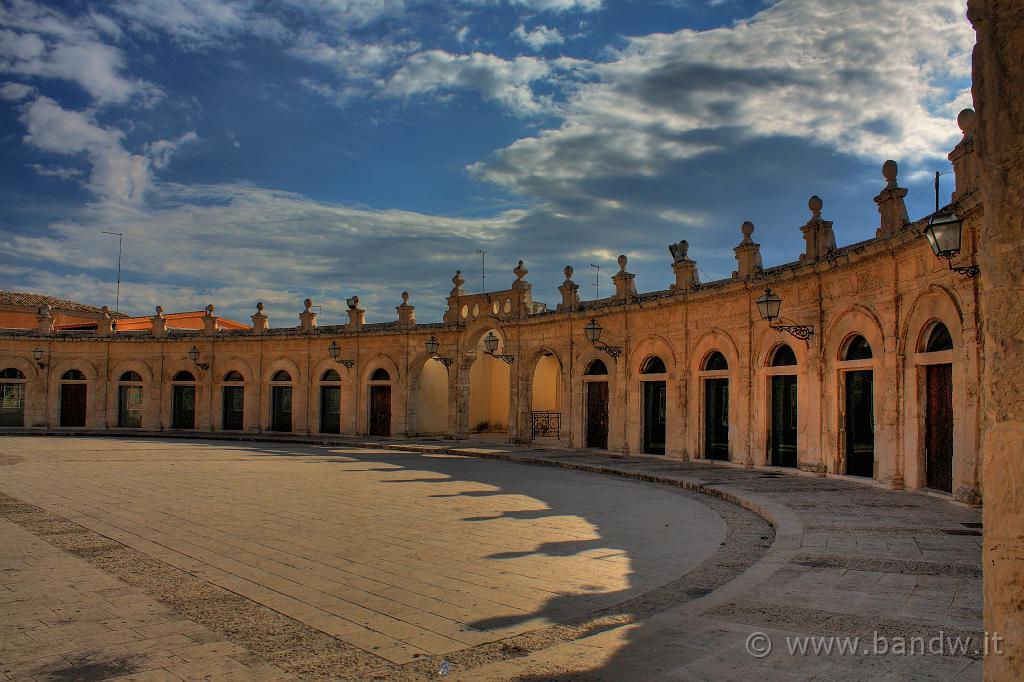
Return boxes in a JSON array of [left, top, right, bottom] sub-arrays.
[[843, 335, 874, 478]]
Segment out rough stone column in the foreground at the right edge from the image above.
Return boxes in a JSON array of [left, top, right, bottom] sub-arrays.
[[968, 0, 1024, 682]]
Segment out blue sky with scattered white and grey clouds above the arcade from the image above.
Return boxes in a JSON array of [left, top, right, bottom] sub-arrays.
[[0, 0, 974, 327]]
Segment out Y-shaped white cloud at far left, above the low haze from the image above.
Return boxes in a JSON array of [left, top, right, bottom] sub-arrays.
[[22, 97, 198, 204]]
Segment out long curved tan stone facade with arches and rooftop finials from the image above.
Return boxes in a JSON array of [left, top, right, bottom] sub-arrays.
[[0, 115, 983, 503]]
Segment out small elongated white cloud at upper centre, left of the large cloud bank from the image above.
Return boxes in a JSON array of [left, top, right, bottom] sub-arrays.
[[384, 50, 552, 116]]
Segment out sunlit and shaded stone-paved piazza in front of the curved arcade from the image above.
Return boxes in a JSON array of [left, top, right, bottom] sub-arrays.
[[0, 436, 981, 682]]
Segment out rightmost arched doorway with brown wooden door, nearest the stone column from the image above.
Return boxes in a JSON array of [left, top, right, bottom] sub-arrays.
[[915, 323, 953, 493]]
